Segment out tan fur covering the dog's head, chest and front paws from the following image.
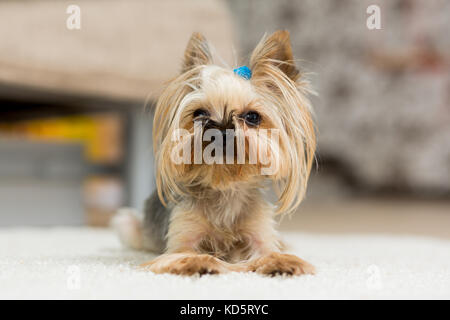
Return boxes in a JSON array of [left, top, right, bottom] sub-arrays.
[[146, 31, 316, 275]]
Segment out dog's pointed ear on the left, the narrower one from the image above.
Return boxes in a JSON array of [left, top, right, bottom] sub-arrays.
[[182, 32, 212, 72]]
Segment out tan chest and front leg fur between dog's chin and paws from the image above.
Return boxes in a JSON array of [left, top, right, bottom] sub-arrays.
[[167, 190, 280, 262]]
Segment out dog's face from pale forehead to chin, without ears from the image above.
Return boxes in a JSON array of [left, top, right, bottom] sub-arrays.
[[166, 65, 280, 190]]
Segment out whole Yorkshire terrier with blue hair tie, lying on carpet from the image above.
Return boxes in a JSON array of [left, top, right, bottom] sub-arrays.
[[114, 31, 316, 276]]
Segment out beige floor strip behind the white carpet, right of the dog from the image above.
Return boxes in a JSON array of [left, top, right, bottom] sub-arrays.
[[280, 198, 450, 239]]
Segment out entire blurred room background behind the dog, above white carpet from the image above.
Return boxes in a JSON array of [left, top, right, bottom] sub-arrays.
[[0, 0, 450, 238]]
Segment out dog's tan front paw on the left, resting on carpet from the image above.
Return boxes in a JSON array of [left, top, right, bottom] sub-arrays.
[[141, 253, 228, 276]]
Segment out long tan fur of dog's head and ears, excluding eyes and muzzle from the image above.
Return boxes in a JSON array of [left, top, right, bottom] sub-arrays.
[[153, 31, 316, 213]]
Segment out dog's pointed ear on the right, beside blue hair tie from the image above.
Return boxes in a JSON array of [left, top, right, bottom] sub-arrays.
[[250, 30, 299, 81]]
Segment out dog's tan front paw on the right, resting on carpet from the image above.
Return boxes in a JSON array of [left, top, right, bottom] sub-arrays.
[[248, 252, 316, 277]]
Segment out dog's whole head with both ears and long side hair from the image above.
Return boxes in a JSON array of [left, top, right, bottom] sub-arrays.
[[154, 31, 315, 211]]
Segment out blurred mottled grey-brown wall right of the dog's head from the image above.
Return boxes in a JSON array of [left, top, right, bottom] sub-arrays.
[[228, 0, 450, 196]]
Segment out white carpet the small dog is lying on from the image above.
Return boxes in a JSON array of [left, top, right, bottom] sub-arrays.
[[0, 228, 450, 299]]
